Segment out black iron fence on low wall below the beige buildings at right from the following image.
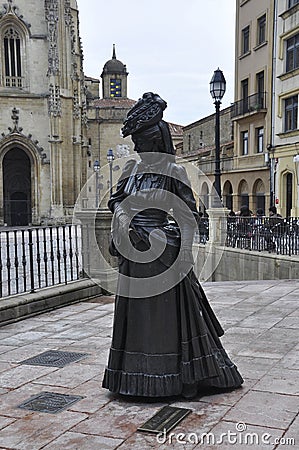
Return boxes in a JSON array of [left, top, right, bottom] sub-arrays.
[[226, 216, 299, 256]]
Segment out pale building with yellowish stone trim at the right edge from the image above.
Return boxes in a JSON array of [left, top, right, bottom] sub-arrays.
[[269, 0, 299, 217]]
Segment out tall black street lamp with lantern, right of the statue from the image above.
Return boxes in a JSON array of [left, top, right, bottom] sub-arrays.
[[210, 68, 226, 208]]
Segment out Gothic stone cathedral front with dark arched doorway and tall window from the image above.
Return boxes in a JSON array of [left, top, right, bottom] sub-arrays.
[[0, 0, 88, 226]]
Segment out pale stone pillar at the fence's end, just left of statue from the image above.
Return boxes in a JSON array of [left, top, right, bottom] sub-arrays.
[[75, 209, 118, 293]]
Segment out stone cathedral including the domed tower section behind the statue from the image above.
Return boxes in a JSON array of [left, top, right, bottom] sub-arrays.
[[0, 0, 182, 226]]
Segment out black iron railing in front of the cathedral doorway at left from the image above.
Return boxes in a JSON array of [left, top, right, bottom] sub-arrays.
[[0, 225, 82, 297]]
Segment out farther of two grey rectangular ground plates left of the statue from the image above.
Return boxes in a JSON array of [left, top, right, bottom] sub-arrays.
[[19, 350, 88, 367]]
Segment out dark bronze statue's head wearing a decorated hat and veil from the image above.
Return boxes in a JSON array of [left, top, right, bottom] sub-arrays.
[[122, 92, 175, 155]]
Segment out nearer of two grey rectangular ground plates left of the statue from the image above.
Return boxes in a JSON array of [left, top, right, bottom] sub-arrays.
[[18, 392, 84, 414]]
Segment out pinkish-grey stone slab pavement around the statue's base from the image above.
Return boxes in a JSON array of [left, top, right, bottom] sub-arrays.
[[0, 280, 299, 450]]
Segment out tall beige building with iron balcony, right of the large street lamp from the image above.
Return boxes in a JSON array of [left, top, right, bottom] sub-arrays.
[[231, 0, 274, 212]]
